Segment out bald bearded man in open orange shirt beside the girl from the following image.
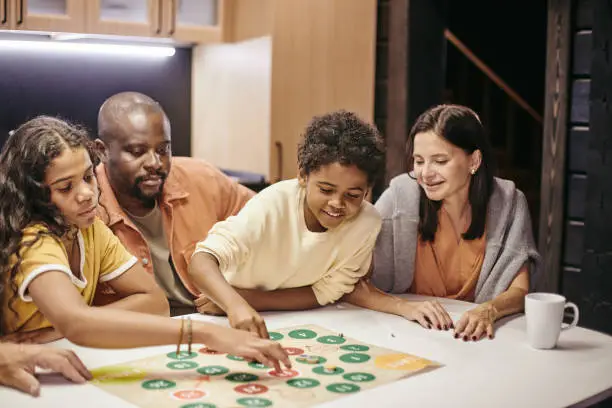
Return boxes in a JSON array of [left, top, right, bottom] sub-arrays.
[[95, 92, 254, 315]]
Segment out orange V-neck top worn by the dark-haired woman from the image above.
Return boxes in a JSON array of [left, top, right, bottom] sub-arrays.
[[410, 209, 486, 302]]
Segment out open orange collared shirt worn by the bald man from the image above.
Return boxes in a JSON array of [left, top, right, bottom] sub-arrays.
[[96, 157, 255, 296]]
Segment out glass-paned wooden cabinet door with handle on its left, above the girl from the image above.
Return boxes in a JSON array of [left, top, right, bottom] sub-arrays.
[[13, 0, 87, 33]]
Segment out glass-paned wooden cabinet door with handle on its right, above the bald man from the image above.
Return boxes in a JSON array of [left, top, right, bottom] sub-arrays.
[[86, 0, 165, 37]]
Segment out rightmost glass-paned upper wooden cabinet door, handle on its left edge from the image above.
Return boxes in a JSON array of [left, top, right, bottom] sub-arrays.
[[163, 0, 225, 43]]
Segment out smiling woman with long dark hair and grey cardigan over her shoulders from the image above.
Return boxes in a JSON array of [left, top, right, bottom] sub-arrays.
[[352, 105, 540, 341]]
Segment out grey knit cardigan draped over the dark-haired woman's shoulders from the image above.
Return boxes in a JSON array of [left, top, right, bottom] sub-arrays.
[[372, 174, 540, 303]]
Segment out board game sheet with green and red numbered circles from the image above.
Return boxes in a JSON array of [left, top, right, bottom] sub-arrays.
[[91, 325, 440, 408]]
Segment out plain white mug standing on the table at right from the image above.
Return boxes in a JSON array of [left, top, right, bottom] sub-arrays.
[[525, 293, 580, 349]]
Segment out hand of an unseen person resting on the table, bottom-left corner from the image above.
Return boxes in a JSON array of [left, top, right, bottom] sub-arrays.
[[0, 343, 92, 397]]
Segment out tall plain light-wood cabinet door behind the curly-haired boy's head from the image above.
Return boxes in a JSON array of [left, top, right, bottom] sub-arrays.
[[270, 0, 377, 180]]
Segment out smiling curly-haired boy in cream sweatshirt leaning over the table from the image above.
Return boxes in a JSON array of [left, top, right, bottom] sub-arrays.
[[189, 111, 384, 337]]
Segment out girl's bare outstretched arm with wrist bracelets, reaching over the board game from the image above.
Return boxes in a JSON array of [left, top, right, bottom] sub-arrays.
[[28, 271, 290, 368]]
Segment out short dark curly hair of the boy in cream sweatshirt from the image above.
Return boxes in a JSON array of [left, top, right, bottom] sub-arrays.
[[298, 110, 385, 185]]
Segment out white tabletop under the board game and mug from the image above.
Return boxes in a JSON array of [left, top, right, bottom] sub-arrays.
[[0, 296, 612, 408]]
